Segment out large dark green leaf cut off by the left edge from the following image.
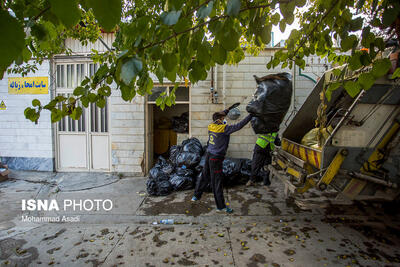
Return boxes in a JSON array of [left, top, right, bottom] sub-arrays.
[[0, 9, 25, 71]]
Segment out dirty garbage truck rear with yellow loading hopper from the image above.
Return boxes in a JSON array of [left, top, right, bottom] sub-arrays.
[[268, 66, 400, 207]]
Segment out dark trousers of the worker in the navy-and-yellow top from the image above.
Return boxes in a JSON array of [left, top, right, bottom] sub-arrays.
[[194, 152, 226, 209]]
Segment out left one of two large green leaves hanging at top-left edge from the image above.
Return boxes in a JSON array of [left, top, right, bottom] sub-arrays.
[[50, 0, 81, 28]]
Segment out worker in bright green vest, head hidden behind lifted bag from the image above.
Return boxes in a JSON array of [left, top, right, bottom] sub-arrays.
[[246, 132, 280, 186]]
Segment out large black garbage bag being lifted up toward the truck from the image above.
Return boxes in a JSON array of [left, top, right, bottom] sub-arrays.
[[246, 72, 292, 134]]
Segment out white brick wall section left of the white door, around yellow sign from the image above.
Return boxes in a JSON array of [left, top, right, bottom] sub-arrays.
[[0, 60, 54, 171]]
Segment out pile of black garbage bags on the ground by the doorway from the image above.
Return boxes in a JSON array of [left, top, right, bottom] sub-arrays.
[[146, 138, 251, 196]]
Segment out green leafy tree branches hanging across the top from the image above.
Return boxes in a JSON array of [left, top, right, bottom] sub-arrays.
[[0, 0, 400, 122]]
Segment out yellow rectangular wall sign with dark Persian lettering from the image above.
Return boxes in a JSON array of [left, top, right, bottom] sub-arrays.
[[8, 77, 49, 95]]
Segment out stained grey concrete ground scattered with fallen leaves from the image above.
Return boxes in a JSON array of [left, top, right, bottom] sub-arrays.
[[0, 171, 400, 266]]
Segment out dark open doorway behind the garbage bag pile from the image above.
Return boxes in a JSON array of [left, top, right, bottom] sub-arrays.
[[146, 85, 191, 173]]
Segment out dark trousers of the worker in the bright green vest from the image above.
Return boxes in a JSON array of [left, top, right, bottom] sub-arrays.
[[250, 144, 272, 185]]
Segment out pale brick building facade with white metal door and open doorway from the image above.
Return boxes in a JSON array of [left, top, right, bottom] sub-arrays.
[[0, 33, 329, 176]]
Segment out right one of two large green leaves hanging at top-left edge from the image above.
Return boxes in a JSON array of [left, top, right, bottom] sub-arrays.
[[86, 0, 122, 31]]
